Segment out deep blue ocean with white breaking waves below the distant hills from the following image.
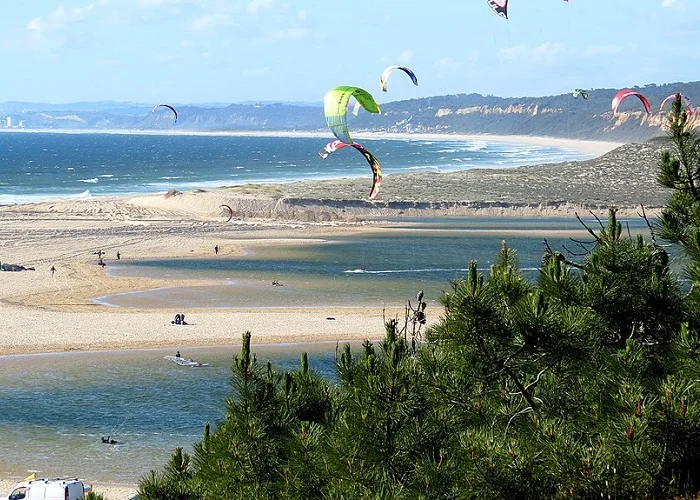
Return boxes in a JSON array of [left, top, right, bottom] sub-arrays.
[[0, 132, 591, 204]]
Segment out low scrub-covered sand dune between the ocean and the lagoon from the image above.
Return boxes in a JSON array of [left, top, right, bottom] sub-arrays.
[[120, 139, 670, 222]]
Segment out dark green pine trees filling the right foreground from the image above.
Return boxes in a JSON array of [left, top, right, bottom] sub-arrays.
[[140, 95, 700, 500]]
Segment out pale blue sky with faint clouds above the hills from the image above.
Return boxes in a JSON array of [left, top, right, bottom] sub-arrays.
[[0, 0, 700, 104]]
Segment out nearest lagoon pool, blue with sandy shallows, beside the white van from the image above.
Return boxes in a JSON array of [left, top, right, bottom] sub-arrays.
[[0, 343, 344, 483]]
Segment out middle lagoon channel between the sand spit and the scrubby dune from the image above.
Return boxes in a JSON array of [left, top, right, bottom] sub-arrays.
[[96, 218, 646, 310]]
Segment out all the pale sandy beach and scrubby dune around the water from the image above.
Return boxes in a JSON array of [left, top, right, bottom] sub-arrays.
[[0, 134, 666, 499]]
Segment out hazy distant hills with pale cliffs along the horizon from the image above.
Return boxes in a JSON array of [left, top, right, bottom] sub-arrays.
[[0, 82, 700, 142]]
